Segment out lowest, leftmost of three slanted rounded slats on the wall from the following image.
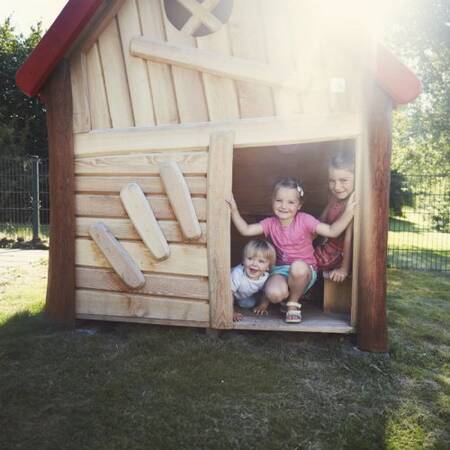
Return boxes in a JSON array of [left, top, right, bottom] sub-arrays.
[[89, 222, 145, 289]]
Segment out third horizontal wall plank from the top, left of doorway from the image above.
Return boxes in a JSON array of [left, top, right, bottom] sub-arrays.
[[75, 194, 206, 220]]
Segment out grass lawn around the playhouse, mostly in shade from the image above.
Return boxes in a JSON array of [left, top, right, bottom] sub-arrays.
[[0, 263, 450, 450]]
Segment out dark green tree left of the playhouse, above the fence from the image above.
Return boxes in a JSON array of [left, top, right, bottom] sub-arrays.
[[0, 18, 47, 157]]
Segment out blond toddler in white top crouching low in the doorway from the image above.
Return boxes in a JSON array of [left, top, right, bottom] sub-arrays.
[[231, 239, 276, 321]]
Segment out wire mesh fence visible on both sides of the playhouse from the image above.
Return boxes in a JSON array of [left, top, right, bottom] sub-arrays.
[[0, 157, 450, 273]]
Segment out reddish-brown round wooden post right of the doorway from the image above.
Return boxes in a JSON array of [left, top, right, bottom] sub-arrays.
[[357, 85, 392, 352]]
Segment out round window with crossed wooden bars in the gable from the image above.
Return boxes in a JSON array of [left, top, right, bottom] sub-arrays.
[[164, 0, 233, 37]]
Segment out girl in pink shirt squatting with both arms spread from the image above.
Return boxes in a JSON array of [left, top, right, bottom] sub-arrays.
[[229, 178, 355, 323]]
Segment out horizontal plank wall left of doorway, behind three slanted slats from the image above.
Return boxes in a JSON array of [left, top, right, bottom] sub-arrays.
[[75, 152, 209, 327]]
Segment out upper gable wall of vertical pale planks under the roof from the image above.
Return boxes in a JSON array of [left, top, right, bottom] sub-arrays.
[[72, 0, 360, 133]]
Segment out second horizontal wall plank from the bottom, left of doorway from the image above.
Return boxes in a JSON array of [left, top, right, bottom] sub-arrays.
[[75, 267, 209, 300]]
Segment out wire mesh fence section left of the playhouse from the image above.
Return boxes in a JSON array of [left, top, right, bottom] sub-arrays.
[[0, 157, 50, 241]]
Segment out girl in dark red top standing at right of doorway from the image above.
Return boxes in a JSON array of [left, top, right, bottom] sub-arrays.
[[314, 151, 355, 282]]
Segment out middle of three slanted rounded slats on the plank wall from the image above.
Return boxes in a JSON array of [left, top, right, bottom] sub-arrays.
[[120, 183, 170, 260]]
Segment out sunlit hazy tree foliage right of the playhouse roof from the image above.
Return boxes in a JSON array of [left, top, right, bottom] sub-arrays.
[[387, 0, 450, 174]]
